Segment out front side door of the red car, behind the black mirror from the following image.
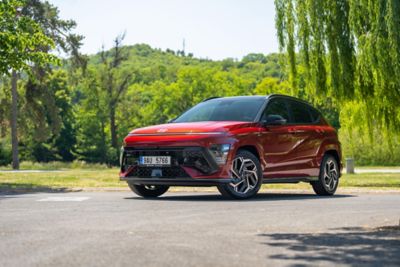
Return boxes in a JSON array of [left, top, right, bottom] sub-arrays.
[[260, 97, 298, 178]]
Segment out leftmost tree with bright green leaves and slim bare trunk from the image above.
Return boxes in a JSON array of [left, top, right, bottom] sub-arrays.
[[0, 0, 57, 169]]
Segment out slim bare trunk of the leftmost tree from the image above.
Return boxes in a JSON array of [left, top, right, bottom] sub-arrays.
[[11, 70, 19, 170]]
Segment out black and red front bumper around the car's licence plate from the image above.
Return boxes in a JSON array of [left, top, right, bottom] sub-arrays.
[[120, 146, 231, 186]]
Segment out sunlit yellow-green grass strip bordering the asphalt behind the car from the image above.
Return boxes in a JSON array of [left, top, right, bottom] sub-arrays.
[[0, 168, 400, 191]]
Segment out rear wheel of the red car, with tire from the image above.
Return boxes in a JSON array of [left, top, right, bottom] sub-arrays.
[[311, 155, 340, 196]]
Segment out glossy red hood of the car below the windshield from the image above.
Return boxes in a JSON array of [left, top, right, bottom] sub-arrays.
[[129, 121, 253, 136]]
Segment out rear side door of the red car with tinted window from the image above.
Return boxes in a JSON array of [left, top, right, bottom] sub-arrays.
[[288, 99, 321, 177]]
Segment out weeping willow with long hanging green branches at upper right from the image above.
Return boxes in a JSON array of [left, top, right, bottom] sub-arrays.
[[275, 0, 400, 132]]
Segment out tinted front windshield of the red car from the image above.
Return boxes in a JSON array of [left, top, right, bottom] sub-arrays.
[[174, 98, 265, 122]]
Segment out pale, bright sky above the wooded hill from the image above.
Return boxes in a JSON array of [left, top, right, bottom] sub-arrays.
[[49, 0, 278, 60]]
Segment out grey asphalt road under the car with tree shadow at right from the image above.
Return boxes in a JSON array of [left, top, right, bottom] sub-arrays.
[[0, 192, 400, 266]]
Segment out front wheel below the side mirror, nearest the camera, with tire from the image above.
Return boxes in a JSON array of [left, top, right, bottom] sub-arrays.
[[218, 150, 262, 199]]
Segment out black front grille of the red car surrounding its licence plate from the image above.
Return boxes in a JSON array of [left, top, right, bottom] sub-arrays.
[[121, 147, 218, 178]]
